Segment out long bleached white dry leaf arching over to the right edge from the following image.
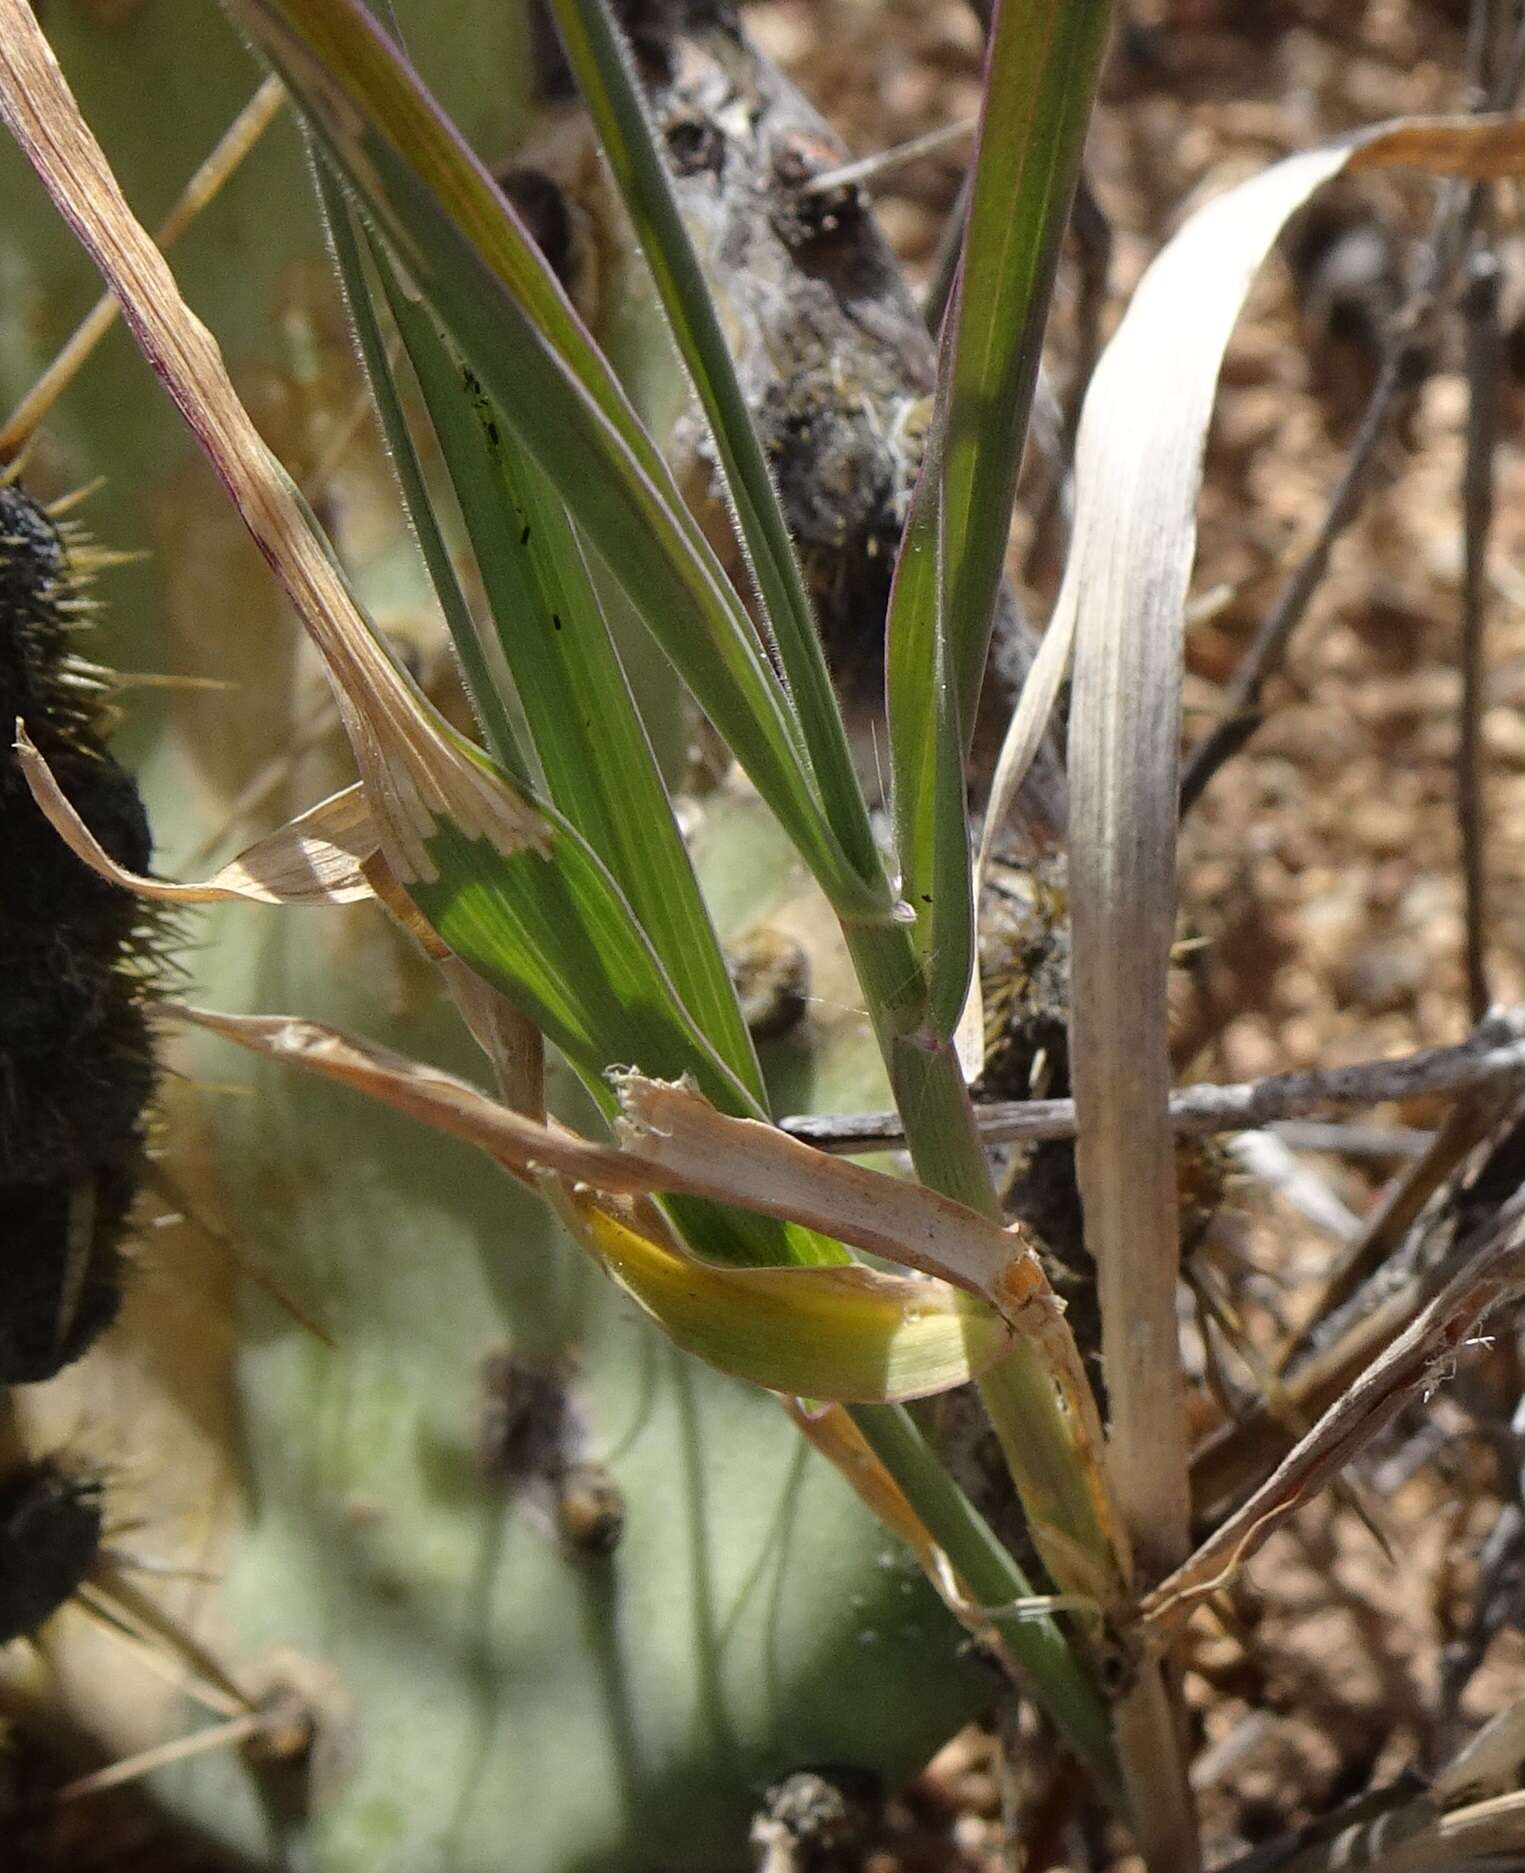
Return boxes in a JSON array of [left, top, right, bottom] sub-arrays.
[[1056, 118, 1525, 1581]]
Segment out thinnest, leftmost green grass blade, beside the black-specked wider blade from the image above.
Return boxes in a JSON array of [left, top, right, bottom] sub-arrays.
[[313, 152, 530, 783]]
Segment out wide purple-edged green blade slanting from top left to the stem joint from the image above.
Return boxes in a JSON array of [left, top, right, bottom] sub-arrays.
[[238, 0, 888, 916]]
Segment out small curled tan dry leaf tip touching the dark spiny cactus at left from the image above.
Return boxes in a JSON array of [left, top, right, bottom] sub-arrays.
[[15, 721, 380, 905]]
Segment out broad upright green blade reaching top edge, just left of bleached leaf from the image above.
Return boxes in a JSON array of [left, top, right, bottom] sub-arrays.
[[942, 0, 1113, 738]]
